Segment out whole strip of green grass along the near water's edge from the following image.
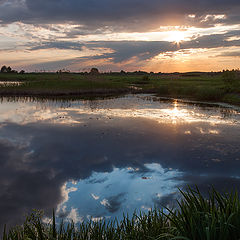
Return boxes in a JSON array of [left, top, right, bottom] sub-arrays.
[[3, 188, 240, 240]]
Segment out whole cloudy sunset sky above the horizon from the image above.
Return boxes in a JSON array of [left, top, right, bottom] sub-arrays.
[[0, 0, 240, 72]]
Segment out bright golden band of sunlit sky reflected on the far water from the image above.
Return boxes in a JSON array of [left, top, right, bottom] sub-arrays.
[[0, 97, 240, 126]]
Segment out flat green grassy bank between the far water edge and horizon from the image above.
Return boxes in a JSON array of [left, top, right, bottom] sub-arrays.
[[0, 73, 240, 104]]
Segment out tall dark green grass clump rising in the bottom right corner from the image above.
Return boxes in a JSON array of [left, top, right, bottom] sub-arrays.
[[167, 188, 240, 240]]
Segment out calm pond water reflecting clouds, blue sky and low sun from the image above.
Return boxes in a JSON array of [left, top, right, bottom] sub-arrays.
[[0, 95, 240, 227]]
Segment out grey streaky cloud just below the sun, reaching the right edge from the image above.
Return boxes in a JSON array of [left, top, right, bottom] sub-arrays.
[[29, 30, 240, 69]]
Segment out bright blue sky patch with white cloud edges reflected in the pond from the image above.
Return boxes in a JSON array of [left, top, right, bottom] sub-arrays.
[[57, 164, 182, 221]]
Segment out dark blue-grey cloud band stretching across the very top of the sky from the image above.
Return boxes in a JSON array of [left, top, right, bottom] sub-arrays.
[[0, 0, 239, 31]]
